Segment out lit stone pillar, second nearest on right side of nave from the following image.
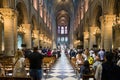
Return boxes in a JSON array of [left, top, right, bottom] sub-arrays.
[[89, 27, 96, 49]]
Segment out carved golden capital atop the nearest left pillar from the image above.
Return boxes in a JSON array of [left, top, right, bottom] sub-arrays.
[[0, 8, 14, 19]]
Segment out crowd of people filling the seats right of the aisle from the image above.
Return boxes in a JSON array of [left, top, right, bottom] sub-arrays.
[[66, 48, 120, 80]]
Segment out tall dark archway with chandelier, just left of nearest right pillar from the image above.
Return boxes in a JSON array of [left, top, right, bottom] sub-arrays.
[[90, 2, 103, 48]]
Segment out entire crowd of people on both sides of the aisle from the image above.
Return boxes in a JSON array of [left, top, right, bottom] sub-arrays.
[[0, 47, 120, 80]]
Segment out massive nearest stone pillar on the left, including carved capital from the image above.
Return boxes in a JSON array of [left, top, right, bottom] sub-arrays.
[[0, 8, 14, 56]]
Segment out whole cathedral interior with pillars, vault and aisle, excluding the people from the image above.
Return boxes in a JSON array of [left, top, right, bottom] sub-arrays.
[[0, 0, 120, 80]]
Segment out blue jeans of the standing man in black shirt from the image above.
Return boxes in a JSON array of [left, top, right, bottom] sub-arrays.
[[30, 69, 42, 80]]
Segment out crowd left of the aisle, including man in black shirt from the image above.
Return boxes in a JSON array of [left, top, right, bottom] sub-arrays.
[[0, 47, 61, 80]]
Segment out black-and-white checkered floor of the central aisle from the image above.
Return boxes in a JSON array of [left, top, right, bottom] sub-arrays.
[[46, 53, 77, 80]]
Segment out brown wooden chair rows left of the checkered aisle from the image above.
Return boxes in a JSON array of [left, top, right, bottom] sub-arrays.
[[0, 56, 56, 80]]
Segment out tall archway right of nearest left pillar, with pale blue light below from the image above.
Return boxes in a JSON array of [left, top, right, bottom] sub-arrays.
[[16, 0, 31, 49]]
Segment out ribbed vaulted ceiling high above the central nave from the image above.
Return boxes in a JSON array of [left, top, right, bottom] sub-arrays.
[[53, 0, 74, 25]]
